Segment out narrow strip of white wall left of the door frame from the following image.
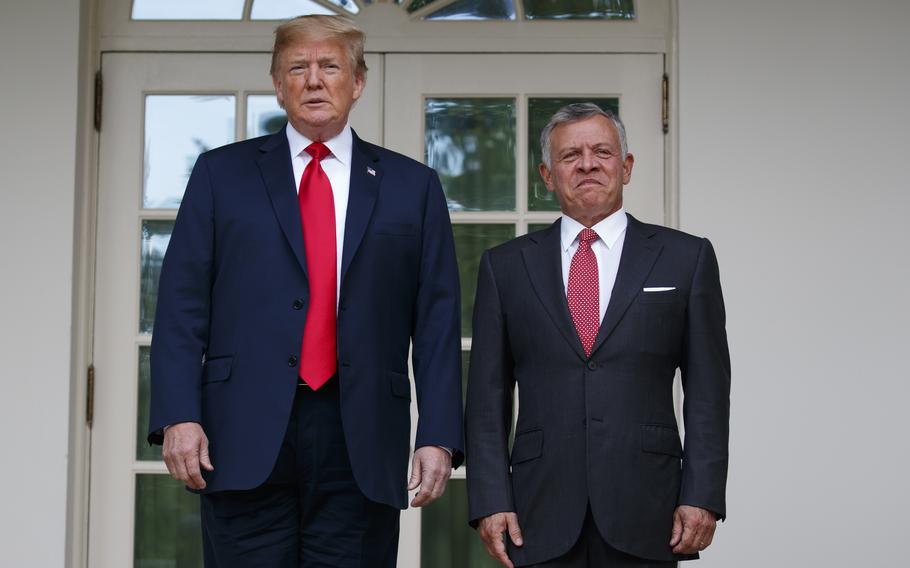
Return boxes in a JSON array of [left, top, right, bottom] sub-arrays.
[[0, 0, 79, 568]]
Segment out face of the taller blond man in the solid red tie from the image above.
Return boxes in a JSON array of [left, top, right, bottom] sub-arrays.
[[272, 39, 364, 142]]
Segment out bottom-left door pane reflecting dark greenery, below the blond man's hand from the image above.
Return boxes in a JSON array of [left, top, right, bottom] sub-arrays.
[[133, 474, 202, 568]]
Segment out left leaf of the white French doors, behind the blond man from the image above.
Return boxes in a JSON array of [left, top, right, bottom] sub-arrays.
[[88, 53, 382, 568]]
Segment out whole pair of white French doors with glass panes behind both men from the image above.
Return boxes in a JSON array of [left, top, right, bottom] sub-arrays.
[[89, 53, 664, 568]]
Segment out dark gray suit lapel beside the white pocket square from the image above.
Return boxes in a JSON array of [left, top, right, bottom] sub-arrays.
[[591, 215, 663, 355]]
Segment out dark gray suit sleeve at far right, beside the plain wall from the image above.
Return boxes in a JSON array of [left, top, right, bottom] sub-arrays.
[[679, 239, 730, 519]]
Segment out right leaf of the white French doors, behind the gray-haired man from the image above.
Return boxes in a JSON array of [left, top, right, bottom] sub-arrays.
[[383, 53, 665, 568]]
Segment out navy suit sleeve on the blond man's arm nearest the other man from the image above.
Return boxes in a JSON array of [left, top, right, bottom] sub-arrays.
[[412, 172, 464, 467]]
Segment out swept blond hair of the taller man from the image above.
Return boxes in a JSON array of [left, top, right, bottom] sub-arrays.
[[269, 15, 367, 79]]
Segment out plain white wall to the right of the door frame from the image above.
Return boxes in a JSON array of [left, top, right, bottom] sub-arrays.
[[679, 0, 910, 568]]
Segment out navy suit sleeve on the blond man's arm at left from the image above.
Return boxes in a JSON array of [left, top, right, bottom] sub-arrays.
[[148, 154, 214, 444]]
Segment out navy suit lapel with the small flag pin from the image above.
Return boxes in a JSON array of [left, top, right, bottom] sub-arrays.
[[341, 132, 382, 284]]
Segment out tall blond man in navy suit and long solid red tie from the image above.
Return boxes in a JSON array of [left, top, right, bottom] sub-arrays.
[[149, 16, 463, 567]]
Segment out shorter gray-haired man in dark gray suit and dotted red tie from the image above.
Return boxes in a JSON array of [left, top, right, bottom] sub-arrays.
[[466, 103, 730, 567]]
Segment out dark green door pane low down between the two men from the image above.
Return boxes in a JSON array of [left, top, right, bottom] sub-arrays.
[[420, 479, 499, 568]]
